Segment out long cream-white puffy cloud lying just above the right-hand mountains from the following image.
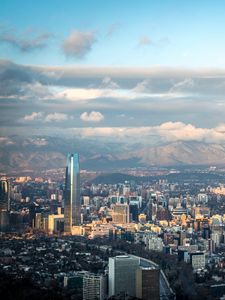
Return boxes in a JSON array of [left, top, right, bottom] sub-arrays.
[[67, 122, 225, 144]]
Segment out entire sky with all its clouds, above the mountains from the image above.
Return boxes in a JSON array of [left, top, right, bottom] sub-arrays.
[[0, 0, 225, 143]]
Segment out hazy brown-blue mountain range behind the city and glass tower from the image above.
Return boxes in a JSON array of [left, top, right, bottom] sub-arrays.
[[0, 136, 225, 173]]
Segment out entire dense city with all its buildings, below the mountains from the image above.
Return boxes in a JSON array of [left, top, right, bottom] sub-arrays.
[[0, 153, 225, 300]]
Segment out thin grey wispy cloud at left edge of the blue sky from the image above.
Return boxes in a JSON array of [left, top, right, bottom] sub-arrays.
[[0, 28, 52, 52]]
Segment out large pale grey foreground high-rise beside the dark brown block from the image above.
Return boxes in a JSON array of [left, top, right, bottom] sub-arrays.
[[109, 255, 140, 297]]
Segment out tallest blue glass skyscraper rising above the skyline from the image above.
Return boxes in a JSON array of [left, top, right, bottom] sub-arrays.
[[64, 153, 81, 233]]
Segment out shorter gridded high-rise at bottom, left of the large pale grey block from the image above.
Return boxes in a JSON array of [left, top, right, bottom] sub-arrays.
[[83, 273, 107, 300]]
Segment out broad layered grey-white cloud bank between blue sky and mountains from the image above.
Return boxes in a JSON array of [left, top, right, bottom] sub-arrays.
[[0, 60, 225, 143]]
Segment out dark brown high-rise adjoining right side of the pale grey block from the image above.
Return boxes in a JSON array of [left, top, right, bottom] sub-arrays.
[[136, 267, 160, 300]]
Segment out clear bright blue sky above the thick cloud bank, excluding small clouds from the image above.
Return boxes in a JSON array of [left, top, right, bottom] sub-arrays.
[[0, 0, 225, 67]]
